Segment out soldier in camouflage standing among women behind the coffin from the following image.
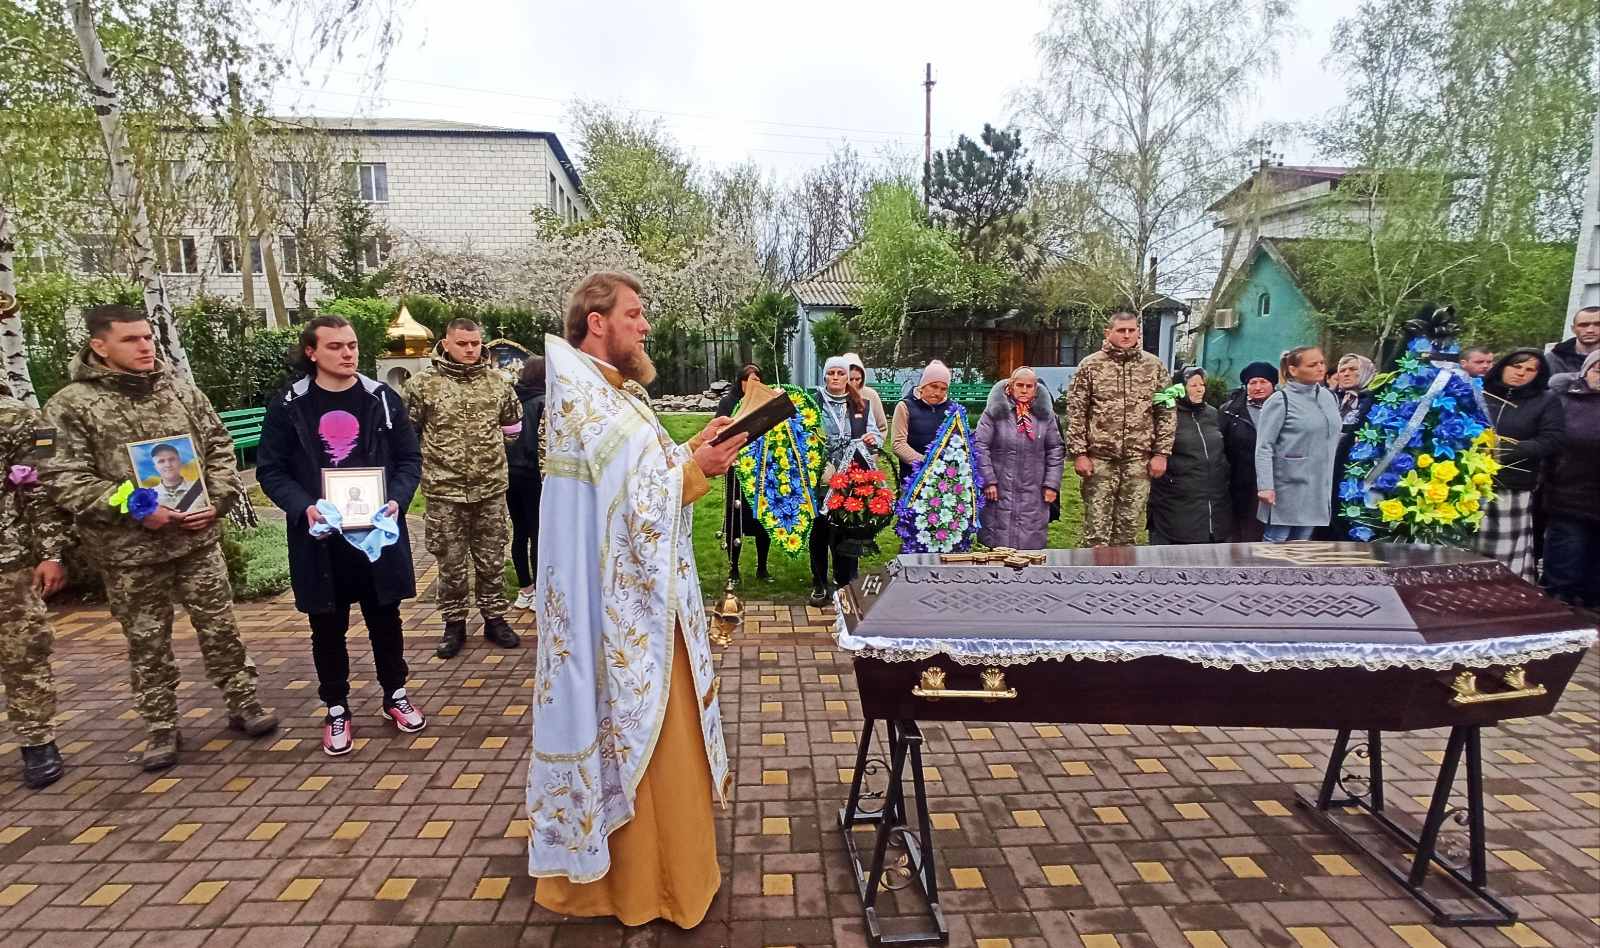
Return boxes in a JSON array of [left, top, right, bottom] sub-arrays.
[[1067, 312, 1178, 546]]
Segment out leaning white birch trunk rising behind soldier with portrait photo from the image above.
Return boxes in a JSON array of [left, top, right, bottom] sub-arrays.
[[72, 0, 194, 380]]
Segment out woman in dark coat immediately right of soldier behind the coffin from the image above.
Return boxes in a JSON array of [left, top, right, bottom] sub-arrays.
[[1149, 365, 1235, 544]]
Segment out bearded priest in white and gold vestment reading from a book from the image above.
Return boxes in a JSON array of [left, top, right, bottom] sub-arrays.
[[528, 272, 744, 929]]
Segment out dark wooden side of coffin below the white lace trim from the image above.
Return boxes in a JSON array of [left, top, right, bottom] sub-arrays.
[[856, 652, 1582, 730]]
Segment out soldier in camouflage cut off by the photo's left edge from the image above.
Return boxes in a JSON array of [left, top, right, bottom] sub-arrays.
[[0, 383, 67, 789]]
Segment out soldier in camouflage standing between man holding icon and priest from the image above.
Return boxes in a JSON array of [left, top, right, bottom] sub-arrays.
[[405, 319, 522, 658]]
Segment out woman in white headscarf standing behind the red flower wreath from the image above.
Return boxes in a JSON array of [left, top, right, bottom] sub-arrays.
[[810, 356, 883, 605]]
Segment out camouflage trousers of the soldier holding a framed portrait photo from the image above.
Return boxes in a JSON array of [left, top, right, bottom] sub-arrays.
[[99, 544, 256, 732]]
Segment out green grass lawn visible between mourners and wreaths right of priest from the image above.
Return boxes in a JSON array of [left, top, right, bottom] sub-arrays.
[[661, 413, 1083, 602]]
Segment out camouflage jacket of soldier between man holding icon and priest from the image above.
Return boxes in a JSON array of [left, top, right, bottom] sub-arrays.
[[405, 354, 522, 503]]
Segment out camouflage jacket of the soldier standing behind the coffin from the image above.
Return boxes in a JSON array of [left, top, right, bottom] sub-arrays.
[[1067, 343, 1178, 461]]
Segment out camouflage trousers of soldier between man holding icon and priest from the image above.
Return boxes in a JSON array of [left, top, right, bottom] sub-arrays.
[[424, 493, 510, 621]]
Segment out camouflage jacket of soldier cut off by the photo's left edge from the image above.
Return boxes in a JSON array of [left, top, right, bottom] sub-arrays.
[[0, 386, 69, 572]]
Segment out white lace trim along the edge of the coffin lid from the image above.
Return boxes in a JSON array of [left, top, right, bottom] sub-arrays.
[[834, 621, 1595, 671]]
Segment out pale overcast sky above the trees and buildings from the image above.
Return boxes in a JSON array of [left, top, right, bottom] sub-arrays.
[[277, 0, 1357, 178]]
